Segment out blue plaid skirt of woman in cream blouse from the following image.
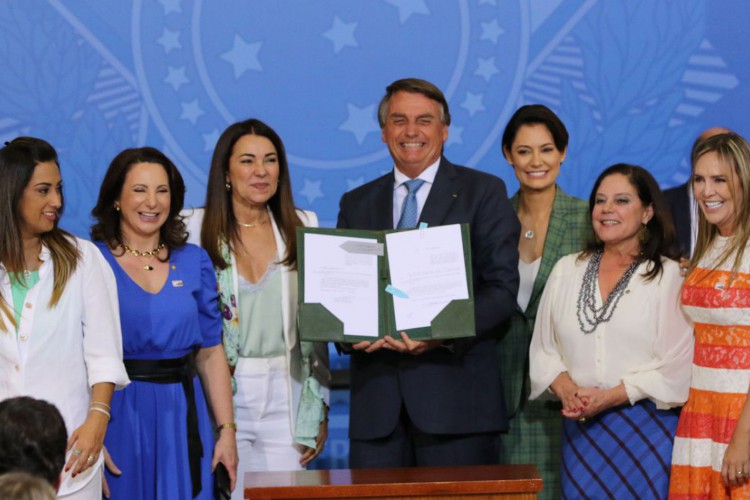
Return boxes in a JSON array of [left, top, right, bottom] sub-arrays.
[[561, 400, 679, 499]]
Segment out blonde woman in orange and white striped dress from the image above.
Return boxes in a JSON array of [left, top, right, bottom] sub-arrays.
[[669, 133, 750, 499]]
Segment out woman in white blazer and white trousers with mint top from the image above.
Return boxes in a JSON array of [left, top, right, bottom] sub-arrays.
[[189, 119, 329, 498]]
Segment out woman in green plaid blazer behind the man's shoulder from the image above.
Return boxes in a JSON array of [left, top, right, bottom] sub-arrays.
[[498, 104, 591, 498]]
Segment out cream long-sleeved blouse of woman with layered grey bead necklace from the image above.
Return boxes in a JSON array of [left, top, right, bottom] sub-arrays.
[[529, 254, 693, 409]]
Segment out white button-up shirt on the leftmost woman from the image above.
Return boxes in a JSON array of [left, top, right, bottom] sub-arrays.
[[0, 238, 129, 496]]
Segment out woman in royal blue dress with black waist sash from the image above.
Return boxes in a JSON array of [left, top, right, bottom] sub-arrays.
[[91, 147, 237, 499]]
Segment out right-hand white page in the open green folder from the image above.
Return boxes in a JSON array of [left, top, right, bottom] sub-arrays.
[[385, 224, 469, 331]]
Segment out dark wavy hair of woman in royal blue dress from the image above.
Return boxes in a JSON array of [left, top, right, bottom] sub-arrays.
[[91, 146, 187, 254]]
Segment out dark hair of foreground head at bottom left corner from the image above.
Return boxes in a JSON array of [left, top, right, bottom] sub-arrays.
[[0, 396, 68, 487]]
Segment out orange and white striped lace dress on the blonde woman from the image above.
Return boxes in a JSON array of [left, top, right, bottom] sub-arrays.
[[669, 239, 750, 500]]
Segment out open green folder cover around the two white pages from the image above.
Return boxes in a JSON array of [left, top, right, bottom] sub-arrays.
[[297, 224, 476, 343]]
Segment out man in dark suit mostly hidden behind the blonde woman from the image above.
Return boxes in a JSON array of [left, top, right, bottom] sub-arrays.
[[664, 127, 731, 267]]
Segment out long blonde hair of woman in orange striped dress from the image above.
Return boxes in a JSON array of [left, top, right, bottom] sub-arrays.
[[688, 132, 750, 283]]
